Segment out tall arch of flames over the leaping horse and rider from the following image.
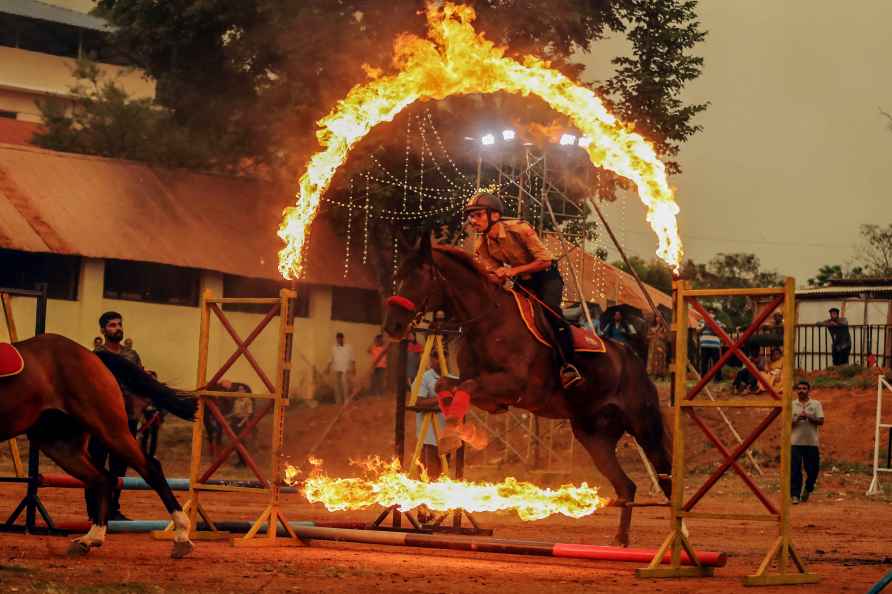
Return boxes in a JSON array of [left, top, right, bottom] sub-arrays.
[[278, 2, 682, 278]]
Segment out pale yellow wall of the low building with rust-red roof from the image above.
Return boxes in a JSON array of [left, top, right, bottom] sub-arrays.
[[0, 258, 380, 395]]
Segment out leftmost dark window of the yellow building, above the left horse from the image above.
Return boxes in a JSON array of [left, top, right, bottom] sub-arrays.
[[0, 249, 81, 301]]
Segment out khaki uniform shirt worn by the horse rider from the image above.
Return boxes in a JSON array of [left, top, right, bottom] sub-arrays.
[[474, 219, 554, 278]]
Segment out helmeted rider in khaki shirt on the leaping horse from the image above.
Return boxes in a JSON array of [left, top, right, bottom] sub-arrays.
[[465, 192, 583, 389]]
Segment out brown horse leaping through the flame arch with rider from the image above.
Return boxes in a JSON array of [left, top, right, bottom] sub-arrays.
[[384, 237, 671, 546]]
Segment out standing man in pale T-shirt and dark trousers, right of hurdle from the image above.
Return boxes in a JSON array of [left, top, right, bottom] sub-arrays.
[[790, 380, 824, 504]]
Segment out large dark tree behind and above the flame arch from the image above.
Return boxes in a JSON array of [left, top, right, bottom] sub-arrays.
[[90, 0, 706, 286]]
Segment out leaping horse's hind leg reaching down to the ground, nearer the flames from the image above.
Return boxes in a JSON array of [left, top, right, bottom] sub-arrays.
[[572, 413, 636, 547]]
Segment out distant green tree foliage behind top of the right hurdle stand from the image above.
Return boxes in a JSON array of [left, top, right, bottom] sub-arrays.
[[681, 253, 783, 328]]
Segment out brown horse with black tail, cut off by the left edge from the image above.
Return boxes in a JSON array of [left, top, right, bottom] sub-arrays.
[[0, 334, 196, 558]]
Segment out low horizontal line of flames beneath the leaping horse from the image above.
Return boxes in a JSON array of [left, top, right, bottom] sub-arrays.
[[285, 457, 607, 521]]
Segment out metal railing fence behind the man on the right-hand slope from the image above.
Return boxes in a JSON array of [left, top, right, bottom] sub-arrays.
[[795, 324, 892, 371]]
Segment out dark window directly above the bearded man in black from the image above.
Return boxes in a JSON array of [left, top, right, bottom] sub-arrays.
[[103, 260, 201, 307]]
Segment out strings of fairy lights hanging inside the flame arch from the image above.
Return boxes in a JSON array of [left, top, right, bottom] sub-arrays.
[[322, 110, 626, 302]]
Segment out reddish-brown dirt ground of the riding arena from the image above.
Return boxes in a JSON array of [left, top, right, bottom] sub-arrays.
[[0, 376, 892, 594]]
